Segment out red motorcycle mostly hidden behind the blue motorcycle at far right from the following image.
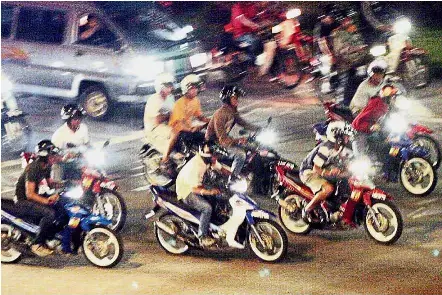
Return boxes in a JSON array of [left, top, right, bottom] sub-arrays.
[[313, 100, 442, 169]]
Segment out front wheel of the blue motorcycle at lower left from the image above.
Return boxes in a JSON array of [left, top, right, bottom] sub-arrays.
[[82, 226, 124, 268]]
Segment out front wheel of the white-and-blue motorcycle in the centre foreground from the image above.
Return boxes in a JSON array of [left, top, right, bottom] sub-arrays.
[[247, 219, 288, 262]]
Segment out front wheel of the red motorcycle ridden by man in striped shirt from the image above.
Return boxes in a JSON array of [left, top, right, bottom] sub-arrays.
[[364, 200, 404, 245]]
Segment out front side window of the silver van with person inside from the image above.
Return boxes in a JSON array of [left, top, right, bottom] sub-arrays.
[[77, 14, 118, 48]]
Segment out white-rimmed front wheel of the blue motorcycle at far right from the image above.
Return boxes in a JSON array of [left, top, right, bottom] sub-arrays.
[[399, 157, 437, 197]]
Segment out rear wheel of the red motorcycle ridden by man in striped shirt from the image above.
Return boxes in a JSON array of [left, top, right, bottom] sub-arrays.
[[278, 195, 312, 235]]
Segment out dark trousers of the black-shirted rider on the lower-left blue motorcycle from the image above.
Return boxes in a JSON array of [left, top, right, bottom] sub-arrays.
[[15, 200, 68, 244]]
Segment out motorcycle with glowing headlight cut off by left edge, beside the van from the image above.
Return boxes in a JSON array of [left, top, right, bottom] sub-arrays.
[[1, 77, 32, 155]]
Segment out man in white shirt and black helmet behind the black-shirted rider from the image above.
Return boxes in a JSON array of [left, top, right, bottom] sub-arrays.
[[51, 104, 89, 149]]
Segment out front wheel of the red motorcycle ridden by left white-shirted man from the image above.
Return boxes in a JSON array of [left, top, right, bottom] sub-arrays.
[[92, 189, 127, 231]]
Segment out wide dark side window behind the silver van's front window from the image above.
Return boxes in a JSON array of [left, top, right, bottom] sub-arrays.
[[16, 8, 66, 44]]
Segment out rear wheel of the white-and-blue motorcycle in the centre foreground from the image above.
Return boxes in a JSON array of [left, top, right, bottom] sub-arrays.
[[154, 213, 189, 255]]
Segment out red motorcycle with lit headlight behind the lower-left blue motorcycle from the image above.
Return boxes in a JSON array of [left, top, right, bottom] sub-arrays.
[[22, 141, 127, 231]]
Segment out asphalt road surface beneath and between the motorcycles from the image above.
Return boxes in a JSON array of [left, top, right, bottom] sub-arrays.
[[1, 76, 442, 294]]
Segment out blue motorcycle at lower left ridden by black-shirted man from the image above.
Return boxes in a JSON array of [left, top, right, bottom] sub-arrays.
[[1, 190, 124, 268]]
